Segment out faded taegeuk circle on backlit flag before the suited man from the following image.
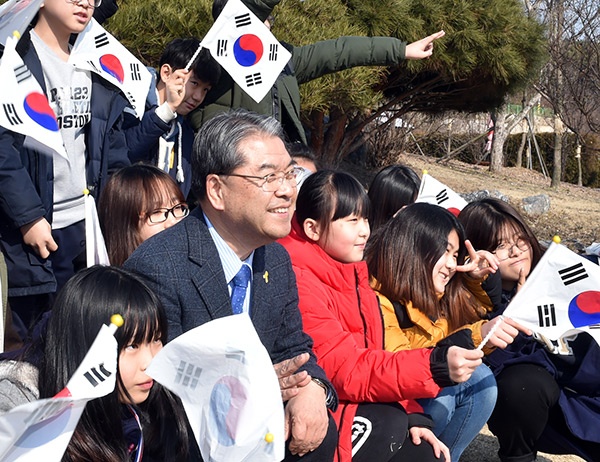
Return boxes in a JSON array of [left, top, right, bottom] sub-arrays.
[[210, 376, 248, 446]]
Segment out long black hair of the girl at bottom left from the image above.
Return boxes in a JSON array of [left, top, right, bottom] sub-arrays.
[[39, 266, 197, 462]]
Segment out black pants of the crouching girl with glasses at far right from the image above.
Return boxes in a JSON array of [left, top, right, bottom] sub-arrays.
[[488, 364, 600, 462]]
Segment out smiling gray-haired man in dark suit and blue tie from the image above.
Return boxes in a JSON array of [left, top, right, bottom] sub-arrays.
[[125, 110, 337, 462]]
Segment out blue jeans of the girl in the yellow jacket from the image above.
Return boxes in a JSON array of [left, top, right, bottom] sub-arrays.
[[418, 364, 498, 462]]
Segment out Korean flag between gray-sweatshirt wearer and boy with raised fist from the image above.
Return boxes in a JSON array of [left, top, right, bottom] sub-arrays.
[[69, 18, 152, 119]]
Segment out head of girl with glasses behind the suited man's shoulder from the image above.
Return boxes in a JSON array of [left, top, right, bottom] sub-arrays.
[[98, 164, 189, 266]]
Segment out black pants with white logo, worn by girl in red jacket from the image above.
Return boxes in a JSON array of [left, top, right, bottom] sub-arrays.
[[352, 403, 443, 462]]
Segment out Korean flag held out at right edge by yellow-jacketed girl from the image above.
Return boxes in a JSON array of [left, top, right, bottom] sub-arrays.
[[504, 242, 600, 354]]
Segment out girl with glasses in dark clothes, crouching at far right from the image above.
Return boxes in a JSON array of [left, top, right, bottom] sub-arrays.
[[459, 198, 600, 462]]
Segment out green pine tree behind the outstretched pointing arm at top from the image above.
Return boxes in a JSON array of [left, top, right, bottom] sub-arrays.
[[107, 0, 545, 164]]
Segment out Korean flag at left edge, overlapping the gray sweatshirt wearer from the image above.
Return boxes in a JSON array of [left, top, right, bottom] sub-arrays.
[[0, 36, 67, 158]]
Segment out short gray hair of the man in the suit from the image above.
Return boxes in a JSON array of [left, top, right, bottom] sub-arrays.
[[192, 109, 284, 200]]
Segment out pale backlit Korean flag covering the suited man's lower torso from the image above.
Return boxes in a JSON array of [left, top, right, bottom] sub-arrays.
[[146, 314, 285, 462]]
